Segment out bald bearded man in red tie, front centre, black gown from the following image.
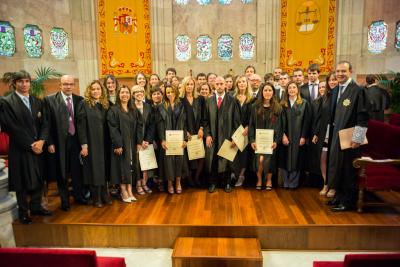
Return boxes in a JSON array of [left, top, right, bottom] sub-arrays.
[[204, 76, 240, 193]]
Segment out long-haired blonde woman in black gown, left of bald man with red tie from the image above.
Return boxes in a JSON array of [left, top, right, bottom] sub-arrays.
[[181, 76, 205, 186]]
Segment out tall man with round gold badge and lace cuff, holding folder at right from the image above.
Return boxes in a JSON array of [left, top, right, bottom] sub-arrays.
[[327, 61, 369, 211]]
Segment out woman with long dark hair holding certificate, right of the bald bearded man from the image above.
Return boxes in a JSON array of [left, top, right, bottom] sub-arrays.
[[249, 83, 282, 190]]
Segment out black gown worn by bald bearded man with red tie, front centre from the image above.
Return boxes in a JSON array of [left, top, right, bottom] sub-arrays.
[[204, 94, 241, 173]]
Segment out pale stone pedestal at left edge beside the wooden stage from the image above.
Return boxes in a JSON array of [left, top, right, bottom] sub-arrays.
[[0, 159, 18, 247]]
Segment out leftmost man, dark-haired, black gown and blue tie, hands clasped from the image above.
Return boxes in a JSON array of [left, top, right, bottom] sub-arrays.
[[0, 71, 52, 224]]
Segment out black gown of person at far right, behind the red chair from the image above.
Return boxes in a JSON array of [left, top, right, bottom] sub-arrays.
[[366, 85, 390, 121]]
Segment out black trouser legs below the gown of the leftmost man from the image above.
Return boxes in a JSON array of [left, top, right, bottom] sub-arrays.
[[16, 187, 42, 217]]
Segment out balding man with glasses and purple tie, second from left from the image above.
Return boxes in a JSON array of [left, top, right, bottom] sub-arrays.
[[45, 75, 87, 211]]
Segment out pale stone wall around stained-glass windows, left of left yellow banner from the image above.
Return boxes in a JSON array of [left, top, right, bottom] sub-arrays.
[[0, 0, 98, 94]]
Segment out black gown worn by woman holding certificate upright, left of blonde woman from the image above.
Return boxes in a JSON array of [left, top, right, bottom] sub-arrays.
[[157, 102, 188, 181]]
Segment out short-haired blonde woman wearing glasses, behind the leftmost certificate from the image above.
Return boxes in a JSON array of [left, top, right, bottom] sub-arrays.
[[132, 85, 152, 195]]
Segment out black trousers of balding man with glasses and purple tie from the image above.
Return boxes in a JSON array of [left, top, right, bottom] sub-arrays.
[[56, 134, 84, 203]]
